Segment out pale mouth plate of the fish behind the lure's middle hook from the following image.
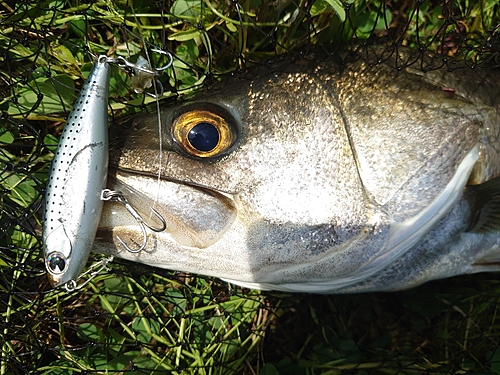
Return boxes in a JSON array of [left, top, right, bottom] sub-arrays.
[[98, 169, 237, 249]]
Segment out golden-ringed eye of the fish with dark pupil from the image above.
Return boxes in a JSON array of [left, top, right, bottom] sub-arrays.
[[172, 109, 236, 158]]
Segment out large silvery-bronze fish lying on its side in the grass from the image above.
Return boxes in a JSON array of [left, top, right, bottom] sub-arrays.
[[93, 52, 500, 293]]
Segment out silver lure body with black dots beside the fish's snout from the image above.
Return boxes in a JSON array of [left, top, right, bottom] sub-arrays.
[[43, 56, 110, 287]]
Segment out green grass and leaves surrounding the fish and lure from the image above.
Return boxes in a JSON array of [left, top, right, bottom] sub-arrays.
[[0, 0, 500, 375]]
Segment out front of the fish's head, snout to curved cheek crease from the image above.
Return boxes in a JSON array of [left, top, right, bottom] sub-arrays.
[[94, 63, 385, 290]]
